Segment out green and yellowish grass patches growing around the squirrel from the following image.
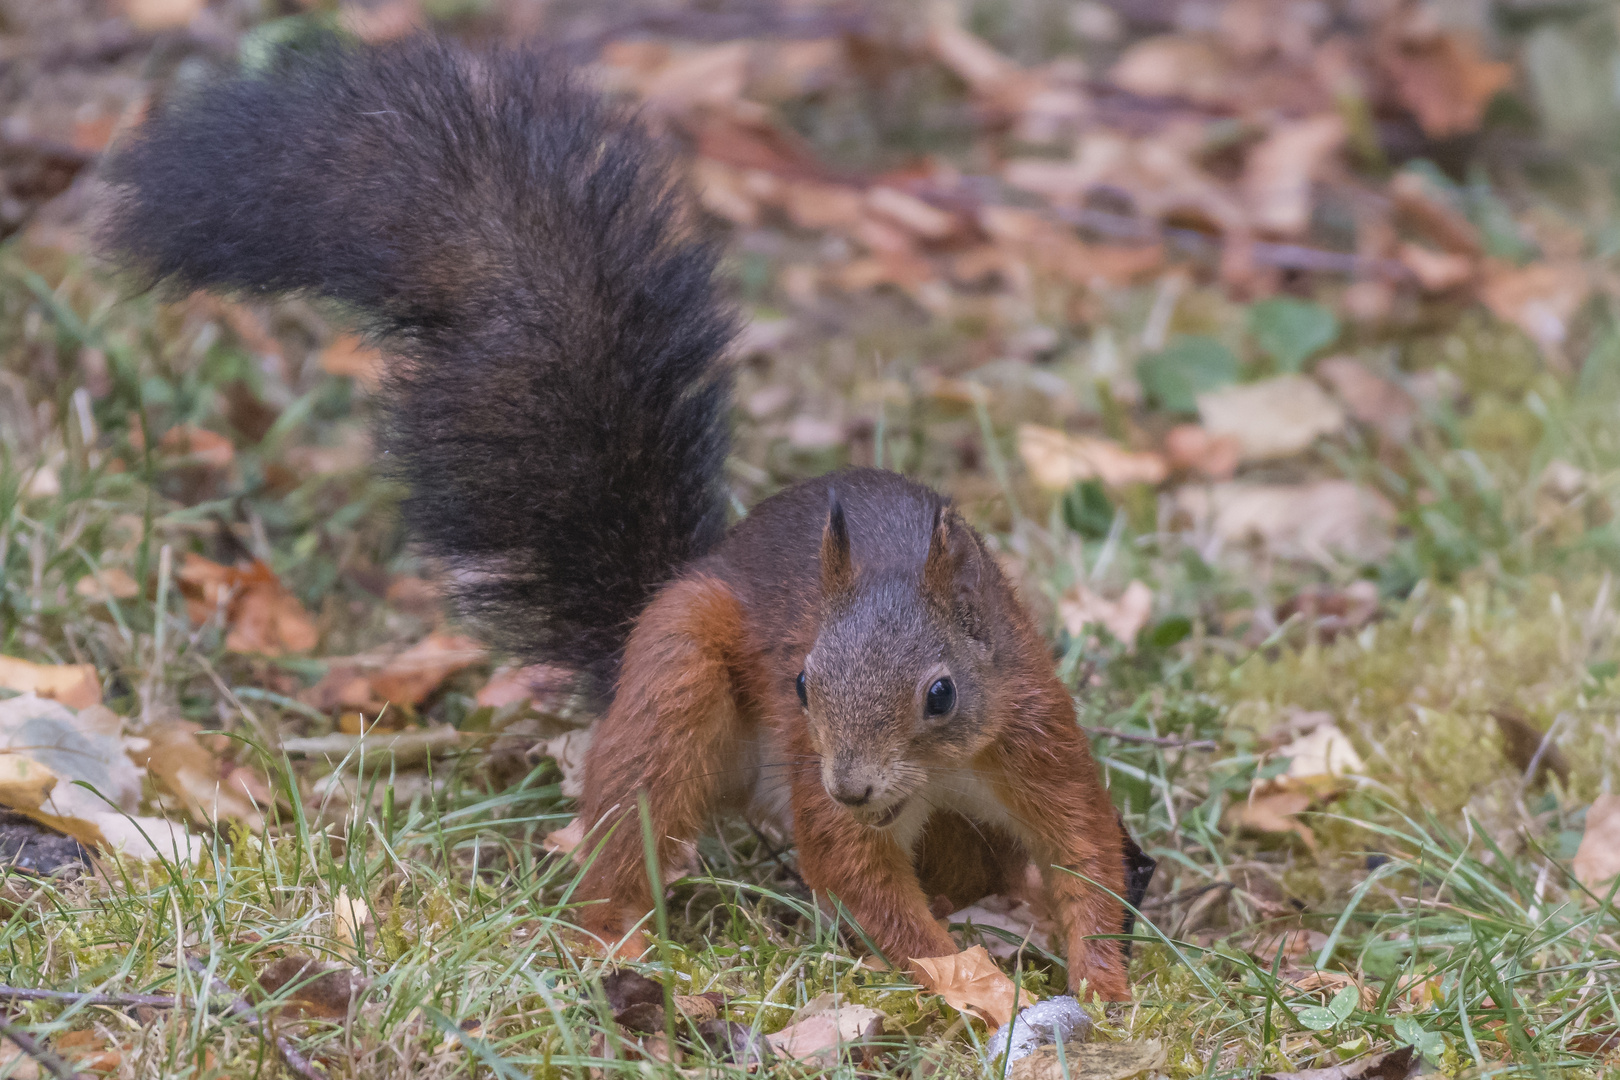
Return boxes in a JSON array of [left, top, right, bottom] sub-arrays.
[[0, 6, 1620, 1080]]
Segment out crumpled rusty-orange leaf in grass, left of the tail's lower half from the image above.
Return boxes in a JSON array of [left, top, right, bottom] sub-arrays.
[[175, 552, 321, 656]]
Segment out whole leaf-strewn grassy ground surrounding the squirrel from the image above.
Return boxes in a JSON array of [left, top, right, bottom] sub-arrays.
[[0, 0, 1620, 1080]]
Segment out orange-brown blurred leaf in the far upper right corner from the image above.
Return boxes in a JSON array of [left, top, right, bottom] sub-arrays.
[[1382, 32, 1513, 139]]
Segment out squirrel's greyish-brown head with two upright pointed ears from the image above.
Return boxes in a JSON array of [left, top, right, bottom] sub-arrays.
[[795, 494, 995, 827]]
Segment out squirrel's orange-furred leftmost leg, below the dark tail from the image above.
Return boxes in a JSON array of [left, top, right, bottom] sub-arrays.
[[578, 573, 744, 944]]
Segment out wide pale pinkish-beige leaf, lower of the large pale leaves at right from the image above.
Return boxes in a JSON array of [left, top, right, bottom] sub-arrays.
[[1176, 479, 1395, 567]]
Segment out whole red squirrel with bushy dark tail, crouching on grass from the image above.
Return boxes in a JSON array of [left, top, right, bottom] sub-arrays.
[[100, 37, 1150, 999]]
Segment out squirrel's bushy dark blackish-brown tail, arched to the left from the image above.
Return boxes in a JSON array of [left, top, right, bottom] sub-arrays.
[[104, 40, 734, 690]]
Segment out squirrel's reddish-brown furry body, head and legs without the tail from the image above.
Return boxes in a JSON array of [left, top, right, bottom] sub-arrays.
[[582, 470, 1129, 999]]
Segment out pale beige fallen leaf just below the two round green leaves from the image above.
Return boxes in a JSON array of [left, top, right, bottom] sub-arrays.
[[1197, 376, 1346, 461]]
